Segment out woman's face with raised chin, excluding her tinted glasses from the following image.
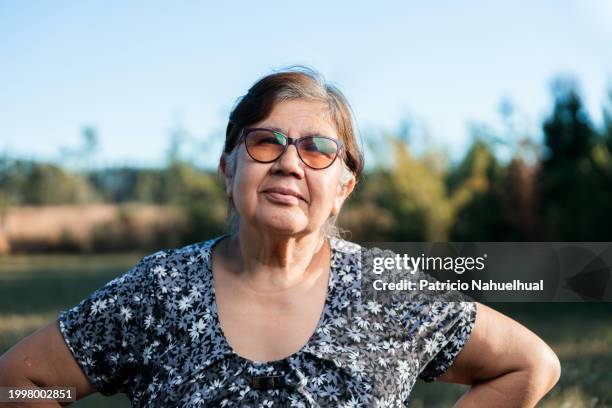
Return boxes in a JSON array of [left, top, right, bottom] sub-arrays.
[[223, 100, 354, 235]]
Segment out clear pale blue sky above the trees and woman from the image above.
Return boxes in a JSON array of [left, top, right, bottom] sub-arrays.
[[0, 0, 612, 165]]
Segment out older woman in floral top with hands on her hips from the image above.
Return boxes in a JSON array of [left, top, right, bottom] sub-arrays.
[[0, 69, 560, 407]]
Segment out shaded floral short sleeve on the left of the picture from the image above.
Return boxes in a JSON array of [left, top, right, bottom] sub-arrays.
[[58, 256, 155, 395]]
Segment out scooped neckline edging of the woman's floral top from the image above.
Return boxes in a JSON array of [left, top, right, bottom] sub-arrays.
[[205, 234, 337, 366]]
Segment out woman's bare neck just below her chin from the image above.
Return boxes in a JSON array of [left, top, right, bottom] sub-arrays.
[[226, 226, 330, 292]]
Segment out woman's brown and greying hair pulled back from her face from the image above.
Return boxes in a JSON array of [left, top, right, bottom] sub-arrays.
[[223, 66, 364, 236]]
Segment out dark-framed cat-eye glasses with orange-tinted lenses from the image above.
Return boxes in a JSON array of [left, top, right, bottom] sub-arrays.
[[241, 128, 342, 170]]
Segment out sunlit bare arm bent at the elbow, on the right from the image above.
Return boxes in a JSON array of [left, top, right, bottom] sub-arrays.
[[439, 303, 561, 408]]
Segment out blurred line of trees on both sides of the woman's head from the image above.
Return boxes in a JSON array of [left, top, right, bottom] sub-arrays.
[[0, 78, 612, 249]]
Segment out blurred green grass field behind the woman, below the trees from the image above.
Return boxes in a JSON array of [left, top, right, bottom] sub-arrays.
[[0, 254, 612, 408]]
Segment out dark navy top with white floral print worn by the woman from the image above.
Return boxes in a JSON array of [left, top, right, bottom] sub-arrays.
[[59, 237, 476, 407]]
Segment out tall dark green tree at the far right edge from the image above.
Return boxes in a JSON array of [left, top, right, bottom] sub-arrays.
[[538, 78, 612, 241]]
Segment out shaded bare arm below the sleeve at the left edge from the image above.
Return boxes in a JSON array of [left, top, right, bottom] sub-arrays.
[[0, 321, 96, 408]]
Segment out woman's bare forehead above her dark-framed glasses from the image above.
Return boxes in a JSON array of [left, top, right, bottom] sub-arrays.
[[256, 99, 336, 137]]
